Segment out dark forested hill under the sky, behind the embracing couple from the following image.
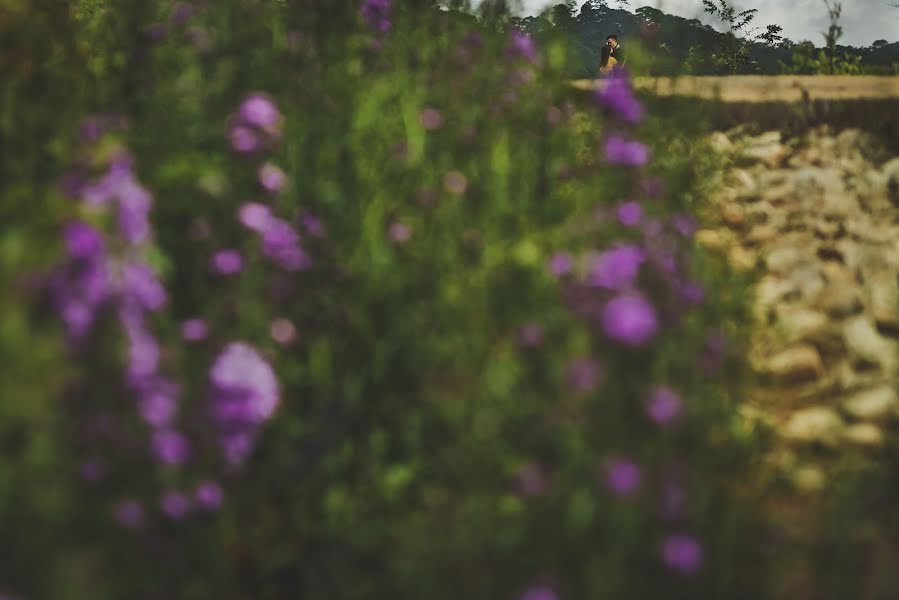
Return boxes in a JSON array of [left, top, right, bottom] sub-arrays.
[[506, 1, 899, 77]]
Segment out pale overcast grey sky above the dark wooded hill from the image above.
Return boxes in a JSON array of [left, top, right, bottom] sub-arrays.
[[510, 0, 899, 46]]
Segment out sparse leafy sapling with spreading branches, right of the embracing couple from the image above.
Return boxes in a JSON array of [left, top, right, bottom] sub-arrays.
[[702, 0, 783, 73]]
